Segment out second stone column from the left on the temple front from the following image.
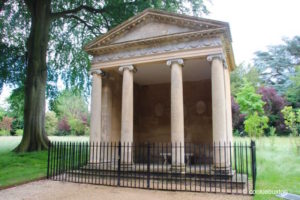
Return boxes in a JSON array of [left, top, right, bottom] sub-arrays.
[[119, 65, 136, 165]]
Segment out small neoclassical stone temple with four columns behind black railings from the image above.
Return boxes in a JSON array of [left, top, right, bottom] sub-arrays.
[[84, 9, 235, 166]]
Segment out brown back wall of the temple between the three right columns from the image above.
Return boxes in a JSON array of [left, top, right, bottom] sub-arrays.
[[134, 80, 212, 144]]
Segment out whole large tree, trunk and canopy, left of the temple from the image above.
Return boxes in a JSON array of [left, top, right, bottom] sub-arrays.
[[0, 0, 207, 152]]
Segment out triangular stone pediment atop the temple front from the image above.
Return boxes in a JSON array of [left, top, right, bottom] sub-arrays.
[[85, 9, 228, 51]]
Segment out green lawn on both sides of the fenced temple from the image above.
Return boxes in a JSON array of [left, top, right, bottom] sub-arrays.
[[0, 137, 300, 199]]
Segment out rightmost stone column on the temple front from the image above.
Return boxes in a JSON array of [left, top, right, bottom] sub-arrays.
[[207, 54, 231, 173]]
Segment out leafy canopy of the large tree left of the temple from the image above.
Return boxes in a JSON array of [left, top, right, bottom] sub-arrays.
[[0, 0, 208, 95]]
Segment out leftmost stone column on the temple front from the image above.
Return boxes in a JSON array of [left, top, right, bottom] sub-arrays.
[[90, 69, 104, 163]]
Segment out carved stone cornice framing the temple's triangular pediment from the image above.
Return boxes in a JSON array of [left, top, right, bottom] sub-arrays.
[[84, 9, 230, 55]]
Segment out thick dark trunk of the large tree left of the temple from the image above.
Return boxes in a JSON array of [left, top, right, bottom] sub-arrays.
[[15, 0, 51, 152]]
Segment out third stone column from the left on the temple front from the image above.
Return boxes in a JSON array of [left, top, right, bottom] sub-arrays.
[[167, 59, 185, 168]]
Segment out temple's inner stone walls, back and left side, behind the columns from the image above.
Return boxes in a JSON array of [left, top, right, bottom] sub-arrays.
[[102, 72, 212, 144]]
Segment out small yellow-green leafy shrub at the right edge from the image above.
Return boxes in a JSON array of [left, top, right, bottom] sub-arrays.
[[281, 106, 300, 136]]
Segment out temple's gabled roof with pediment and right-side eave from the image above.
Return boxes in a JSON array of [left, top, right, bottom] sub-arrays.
[[84, 9, 234, 68]]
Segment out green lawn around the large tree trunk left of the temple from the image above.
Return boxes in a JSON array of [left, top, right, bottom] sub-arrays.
[[0, 136, 88, 188]]
